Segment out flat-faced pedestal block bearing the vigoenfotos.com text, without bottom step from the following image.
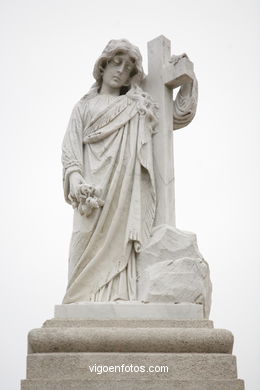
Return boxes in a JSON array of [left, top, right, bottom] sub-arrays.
[[27, 353, 237, 381]]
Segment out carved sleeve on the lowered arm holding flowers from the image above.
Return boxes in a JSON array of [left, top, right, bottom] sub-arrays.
[[62, 103, 83, 203]]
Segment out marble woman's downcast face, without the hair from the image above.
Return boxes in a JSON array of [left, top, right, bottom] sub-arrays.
[[103, 53, 134, 89]]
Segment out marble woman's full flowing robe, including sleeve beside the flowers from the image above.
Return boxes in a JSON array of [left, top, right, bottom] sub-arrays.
[[62, 95, 156, 303]]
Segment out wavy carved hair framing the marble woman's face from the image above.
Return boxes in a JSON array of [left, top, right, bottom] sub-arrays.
[[93, 39, 144, 93]]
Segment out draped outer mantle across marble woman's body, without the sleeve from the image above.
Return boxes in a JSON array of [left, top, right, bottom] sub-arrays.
[[63, 95, 156, 303]]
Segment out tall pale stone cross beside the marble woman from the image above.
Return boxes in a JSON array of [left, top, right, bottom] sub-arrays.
[[142, 35, 193, 226]]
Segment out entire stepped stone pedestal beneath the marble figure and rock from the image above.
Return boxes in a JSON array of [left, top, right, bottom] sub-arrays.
[[21, 303, 244, 390]]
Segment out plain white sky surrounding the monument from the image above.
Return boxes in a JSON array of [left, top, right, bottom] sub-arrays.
[[0, 0, 260, 390]]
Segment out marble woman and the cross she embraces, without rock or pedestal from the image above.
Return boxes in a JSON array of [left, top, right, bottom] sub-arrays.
[[62, 39, 205, 304]]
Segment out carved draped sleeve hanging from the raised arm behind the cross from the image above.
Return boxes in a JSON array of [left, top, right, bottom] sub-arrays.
[[173, 77, 198, 130]]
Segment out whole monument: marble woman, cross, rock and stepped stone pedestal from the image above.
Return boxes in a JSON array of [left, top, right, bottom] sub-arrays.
[[21, 36, 244, 390]]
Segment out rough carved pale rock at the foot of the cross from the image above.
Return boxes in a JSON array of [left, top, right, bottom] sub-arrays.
[[137, 225, 212, 318]]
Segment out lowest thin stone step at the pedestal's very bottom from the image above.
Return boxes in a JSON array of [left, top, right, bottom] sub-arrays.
[[21, 379, 244, 390]]
